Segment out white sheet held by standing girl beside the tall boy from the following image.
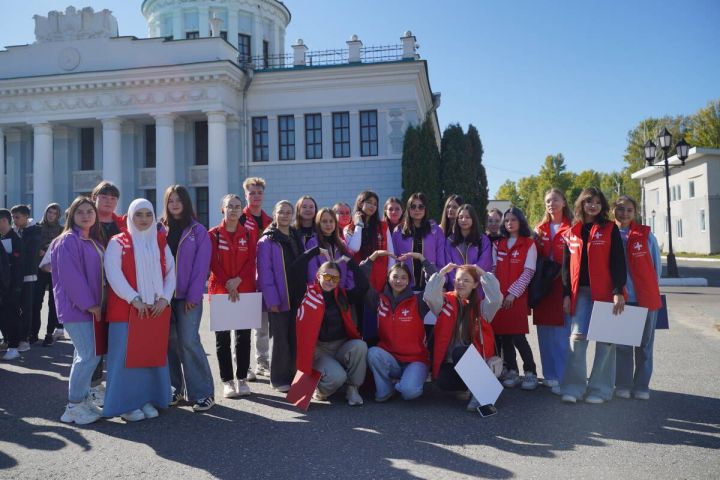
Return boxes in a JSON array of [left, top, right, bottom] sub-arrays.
[[210, 292, 262, 332]]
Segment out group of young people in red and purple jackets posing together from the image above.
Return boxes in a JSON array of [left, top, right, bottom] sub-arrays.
[[0, 177, 661, 424]]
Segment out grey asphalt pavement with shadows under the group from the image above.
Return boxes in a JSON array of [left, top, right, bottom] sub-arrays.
[[0, 266, 720, 480]]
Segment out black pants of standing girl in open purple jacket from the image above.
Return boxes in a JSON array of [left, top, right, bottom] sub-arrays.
[[268, 310, 297, 387]]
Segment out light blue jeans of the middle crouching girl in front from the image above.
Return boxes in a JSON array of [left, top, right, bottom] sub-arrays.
[[368, 347, 428, 400]]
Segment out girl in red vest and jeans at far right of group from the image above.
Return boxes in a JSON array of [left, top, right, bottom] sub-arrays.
[[613, 195, 662, 400]]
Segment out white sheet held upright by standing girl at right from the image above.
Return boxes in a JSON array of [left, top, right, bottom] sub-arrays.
[[588, 302, 647, 347]]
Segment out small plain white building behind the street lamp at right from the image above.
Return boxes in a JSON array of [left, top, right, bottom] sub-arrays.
[[632, 148, 720, 254]]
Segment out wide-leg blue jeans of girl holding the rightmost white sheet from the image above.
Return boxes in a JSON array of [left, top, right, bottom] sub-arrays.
[[560, 287, 615, 400]]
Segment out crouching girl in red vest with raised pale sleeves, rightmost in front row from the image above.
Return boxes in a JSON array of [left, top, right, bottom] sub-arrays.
[[423, 263, 502, 411]]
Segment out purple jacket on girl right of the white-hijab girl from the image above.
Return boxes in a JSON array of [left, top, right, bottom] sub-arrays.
[[175, 220, 212, 304]]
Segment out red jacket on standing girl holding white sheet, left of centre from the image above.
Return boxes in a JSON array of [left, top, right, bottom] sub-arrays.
[[208, 221, 257, 294]]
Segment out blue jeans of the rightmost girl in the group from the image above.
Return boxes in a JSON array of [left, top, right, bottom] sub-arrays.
[[615, 310, 658, 393]]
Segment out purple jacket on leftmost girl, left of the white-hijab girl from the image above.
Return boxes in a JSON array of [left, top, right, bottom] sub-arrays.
[[50, 230, 105, 323]]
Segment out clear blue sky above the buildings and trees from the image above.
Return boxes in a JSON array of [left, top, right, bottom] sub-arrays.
[[0, 0, 720, 196]]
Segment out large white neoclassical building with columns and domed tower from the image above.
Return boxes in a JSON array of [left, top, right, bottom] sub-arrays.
[[0, 0, 439, 224]]
